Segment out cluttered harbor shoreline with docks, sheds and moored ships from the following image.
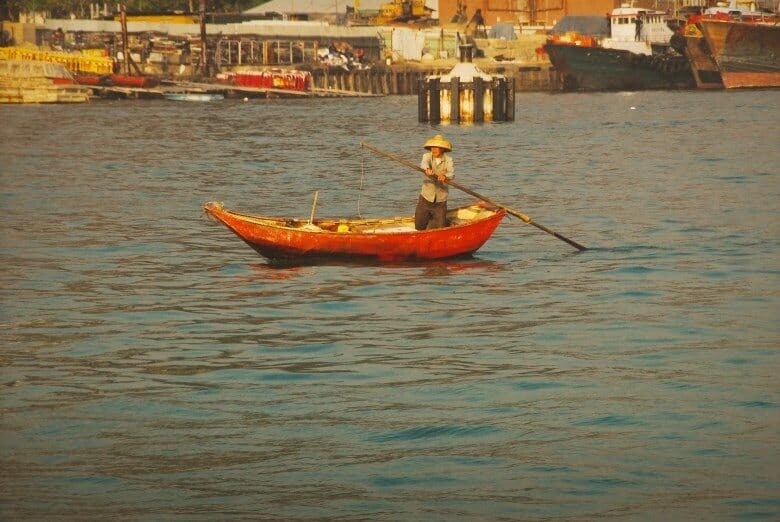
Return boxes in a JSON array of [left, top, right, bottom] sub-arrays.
[[0, 0, 780, 100]]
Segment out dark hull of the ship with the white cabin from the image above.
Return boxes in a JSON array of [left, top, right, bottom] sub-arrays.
[[544, 42, 696, 91]]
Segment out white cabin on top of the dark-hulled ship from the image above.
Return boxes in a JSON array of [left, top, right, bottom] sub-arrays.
[[602, 4, 674, 54]]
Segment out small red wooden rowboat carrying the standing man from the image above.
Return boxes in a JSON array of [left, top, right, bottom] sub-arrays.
[[203, 201, 506, 261]]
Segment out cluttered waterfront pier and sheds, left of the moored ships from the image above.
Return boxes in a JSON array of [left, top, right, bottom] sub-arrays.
[[5, 16, 560, 98]]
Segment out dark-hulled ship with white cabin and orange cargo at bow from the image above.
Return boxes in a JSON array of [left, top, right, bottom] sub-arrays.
[[543, 4, 696, 91]]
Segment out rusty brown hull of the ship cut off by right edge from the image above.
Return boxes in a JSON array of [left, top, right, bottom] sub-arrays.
[[700, 20, 780, 89]]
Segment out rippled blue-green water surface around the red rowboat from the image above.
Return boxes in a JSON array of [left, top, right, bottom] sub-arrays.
[[0, 91, 780, 520]]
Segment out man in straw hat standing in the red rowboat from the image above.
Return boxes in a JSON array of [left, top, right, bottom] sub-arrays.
[[414, 134, 455, 230]]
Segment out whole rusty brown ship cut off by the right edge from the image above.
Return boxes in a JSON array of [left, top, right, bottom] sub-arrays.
[[673, 0, 780, 89]]
